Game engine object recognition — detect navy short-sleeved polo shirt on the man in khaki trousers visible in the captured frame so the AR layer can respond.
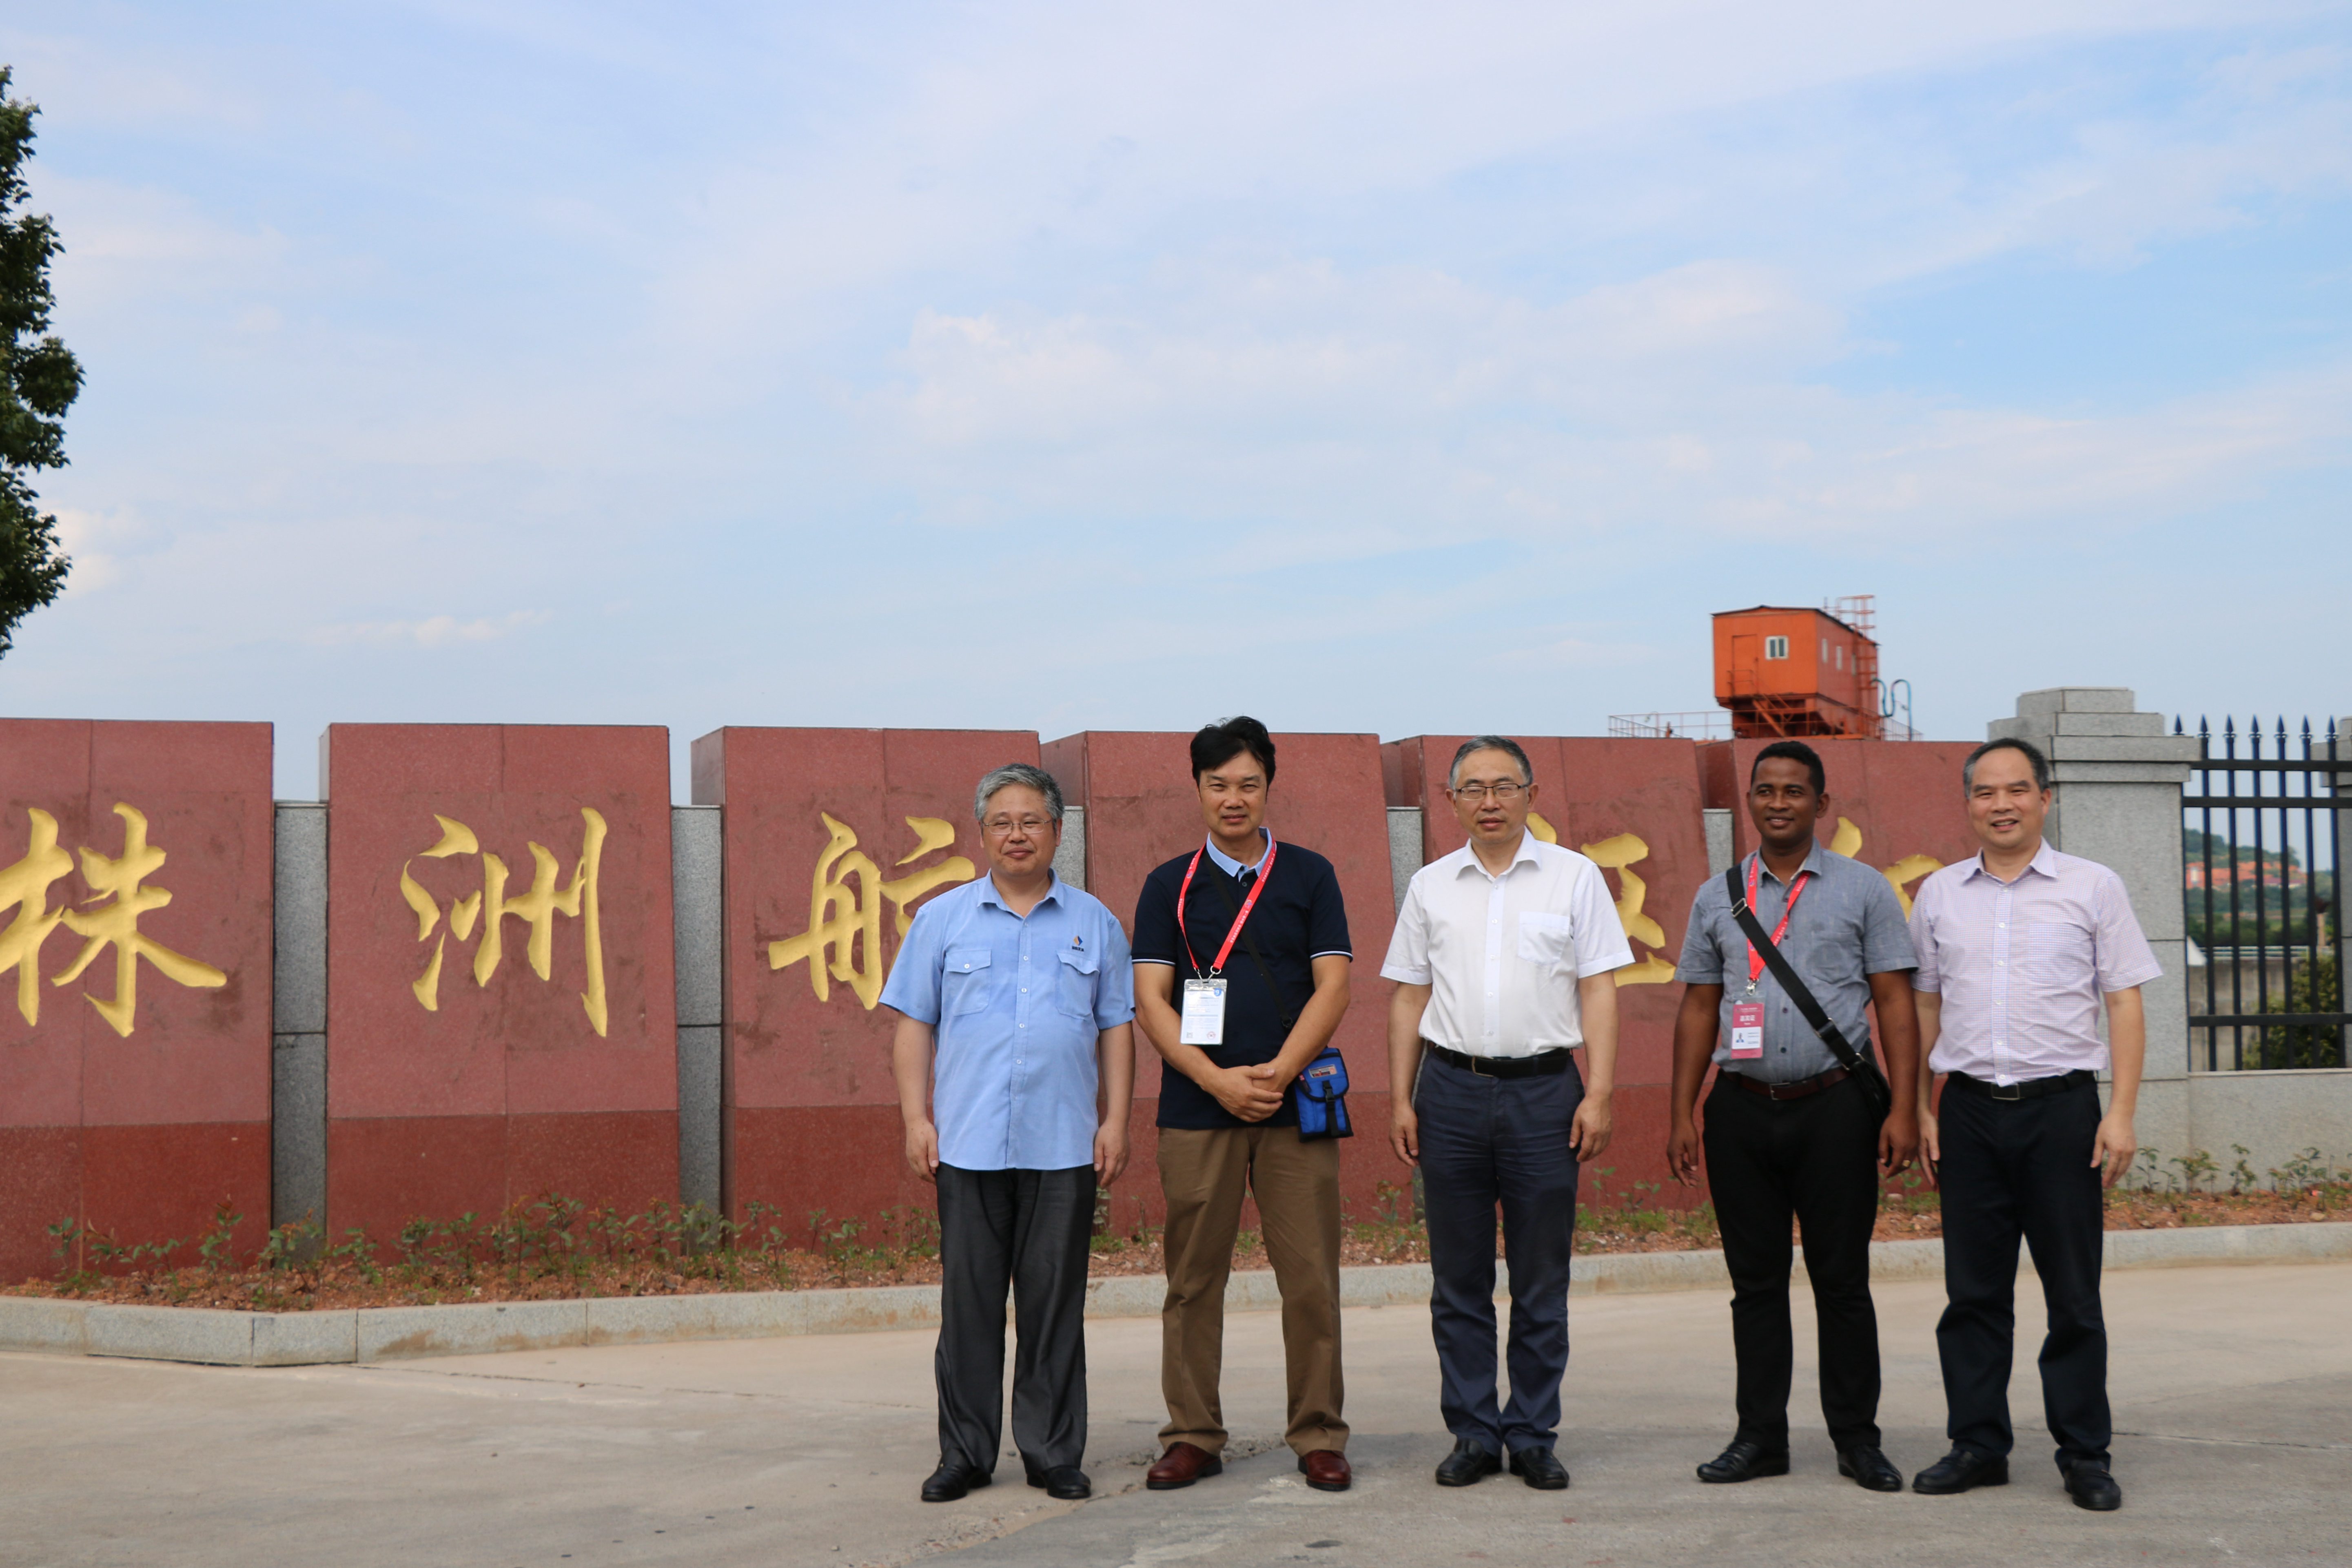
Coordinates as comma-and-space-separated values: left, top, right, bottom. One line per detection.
1136, 839, 1355, 1128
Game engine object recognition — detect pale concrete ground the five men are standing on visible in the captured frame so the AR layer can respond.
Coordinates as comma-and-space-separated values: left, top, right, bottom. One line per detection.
0, 1265, 2352, 1568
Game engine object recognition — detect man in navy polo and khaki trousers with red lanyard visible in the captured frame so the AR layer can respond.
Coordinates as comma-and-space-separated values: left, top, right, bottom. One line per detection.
1136, 720, 1352, 1493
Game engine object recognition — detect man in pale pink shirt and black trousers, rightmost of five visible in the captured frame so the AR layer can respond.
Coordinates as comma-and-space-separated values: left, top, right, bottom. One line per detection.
1912, 740, 2161, 1512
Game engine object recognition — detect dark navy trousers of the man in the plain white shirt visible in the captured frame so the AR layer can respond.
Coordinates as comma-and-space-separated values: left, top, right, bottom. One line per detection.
1414, 1056, 1585, 1453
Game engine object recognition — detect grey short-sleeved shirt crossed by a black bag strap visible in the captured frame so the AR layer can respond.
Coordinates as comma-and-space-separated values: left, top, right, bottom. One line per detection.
1675, 844, 1919, 1084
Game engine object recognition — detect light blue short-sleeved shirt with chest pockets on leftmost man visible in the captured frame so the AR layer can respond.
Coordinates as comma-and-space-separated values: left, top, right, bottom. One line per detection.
882, 877, 1136, 1171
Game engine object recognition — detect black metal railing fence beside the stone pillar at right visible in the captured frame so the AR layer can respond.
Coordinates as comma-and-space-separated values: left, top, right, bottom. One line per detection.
2173, 717, 2352, 1072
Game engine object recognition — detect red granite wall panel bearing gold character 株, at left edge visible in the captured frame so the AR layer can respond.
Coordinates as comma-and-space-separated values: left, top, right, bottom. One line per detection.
0, 720, 273, 1281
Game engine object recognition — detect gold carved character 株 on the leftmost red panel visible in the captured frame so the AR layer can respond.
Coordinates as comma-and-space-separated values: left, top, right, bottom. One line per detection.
0, 802, 228, 1034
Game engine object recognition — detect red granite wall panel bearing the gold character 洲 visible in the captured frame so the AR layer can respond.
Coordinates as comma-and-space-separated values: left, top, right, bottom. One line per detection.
320, 724, 677, 1241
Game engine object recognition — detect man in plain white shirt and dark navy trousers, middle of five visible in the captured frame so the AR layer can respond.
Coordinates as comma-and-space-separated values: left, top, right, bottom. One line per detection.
1381, 736, 1632, 1490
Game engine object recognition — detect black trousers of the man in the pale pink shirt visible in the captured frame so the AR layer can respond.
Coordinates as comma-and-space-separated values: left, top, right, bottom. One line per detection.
1936, 1084, 2115, 1469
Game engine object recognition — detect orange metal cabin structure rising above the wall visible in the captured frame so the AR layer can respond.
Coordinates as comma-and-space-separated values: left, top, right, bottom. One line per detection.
1715, 595, 1886, 740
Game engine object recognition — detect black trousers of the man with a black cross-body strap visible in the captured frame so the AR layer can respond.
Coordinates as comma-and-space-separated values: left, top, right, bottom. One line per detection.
1705, 1074, 1879, 1451
